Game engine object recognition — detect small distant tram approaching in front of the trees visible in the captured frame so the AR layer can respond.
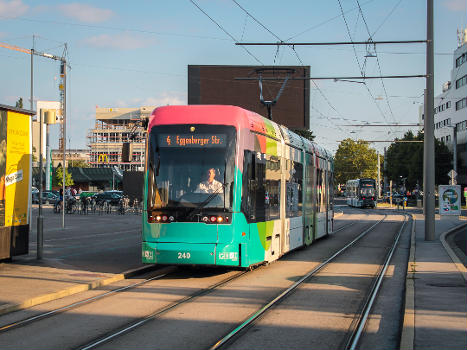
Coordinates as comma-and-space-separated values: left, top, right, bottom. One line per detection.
346, 179, 376, 208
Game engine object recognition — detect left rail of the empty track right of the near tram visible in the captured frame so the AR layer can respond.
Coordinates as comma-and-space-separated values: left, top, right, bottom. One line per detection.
209, 214, 387, 350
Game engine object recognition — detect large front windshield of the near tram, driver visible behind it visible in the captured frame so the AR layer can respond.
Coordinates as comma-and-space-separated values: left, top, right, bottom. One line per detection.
148, 125, 236, 211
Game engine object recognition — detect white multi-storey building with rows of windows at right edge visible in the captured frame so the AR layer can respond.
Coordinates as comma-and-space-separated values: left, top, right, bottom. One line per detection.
420, 29, 467, 186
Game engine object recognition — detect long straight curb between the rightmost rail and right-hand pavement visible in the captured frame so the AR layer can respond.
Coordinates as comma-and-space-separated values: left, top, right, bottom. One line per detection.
399, 214, 417, 350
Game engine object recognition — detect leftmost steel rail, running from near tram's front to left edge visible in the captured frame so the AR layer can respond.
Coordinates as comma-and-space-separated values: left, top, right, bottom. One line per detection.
0, 272, 170, 333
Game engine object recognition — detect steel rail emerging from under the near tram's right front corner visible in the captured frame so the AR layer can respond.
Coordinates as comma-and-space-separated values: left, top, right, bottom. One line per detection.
78, 271, 249, 350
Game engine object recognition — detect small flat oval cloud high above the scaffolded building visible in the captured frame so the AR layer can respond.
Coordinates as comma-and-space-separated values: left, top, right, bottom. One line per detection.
84, 33, 152, 50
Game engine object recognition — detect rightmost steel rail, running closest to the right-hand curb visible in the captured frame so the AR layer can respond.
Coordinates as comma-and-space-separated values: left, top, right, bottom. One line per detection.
345, 215, 407, 350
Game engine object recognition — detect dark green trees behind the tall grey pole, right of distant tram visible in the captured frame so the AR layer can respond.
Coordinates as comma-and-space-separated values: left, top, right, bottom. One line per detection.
385, 131, 452, 189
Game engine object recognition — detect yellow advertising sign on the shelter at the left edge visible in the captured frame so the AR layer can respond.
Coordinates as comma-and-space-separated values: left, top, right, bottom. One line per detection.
5, 111, 31, 226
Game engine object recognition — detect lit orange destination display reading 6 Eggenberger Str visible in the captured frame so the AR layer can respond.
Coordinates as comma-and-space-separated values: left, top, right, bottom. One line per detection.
158, 134, 227, 148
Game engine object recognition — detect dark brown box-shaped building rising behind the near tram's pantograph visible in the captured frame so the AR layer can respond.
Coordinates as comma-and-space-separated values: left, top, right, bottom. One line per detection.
188, 65, 310, 129
